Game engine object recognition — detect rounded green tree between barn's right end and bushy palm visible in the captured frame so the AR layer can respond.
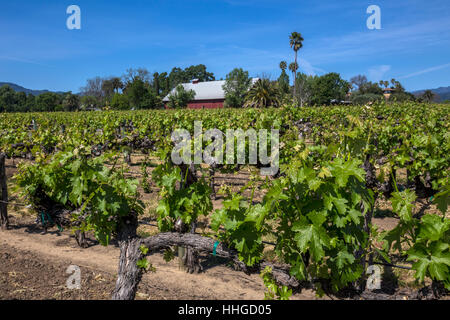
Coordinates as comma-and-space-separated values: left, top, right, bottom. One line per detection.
223, 68, 252, 108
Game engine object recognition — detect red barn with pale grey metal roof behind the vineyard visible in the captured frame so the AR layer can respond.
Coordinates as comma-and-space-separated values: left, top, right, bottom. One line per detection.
163, 79, 257, 109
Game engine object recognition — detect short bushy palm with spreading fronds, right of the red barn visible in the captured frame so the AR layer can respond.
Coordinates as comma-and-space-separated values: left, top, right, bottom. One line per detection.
244, 79, 280, 108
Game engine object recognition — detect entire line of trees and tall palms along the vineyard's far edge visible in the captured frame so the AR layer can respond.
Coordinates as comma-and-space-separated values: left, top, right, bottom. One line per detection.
0, 32, 442, 112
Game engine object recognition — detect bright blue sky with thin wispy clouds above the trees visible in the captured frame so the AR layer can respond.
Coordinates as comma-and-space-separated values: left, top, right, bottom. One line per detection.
0, 0, 450, 92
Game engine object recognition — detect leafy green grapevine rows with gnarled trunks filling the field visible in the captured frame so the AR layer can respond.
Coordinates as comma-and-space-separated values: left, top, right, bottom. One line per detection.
0, 102, 450, 300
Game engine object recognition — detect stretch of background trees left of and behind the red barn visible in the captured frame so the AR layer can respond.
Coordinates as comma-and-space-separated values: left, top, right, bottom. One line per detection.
0, 64, 215, 112
